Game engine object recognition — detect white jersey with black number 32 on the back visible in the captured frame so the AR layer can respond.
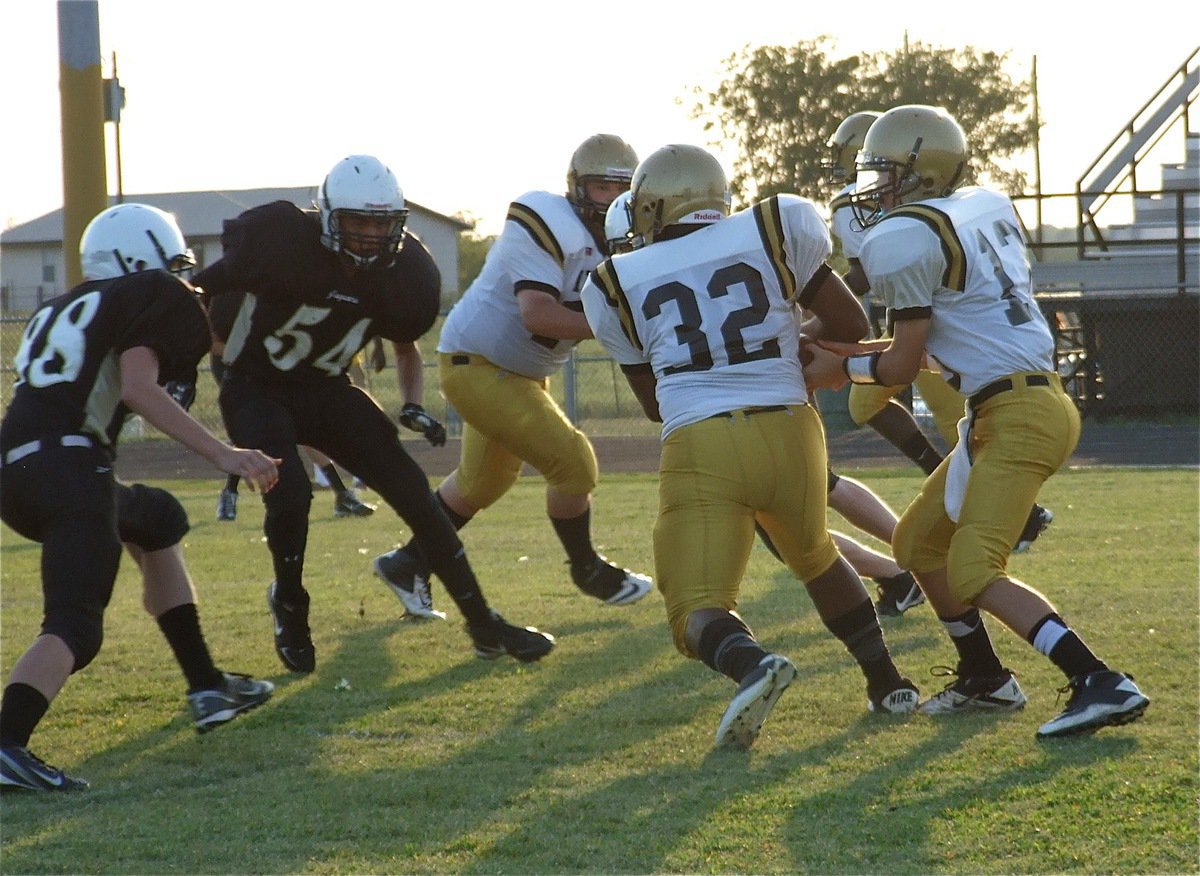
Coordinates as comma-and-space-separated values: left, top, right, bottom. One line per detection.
583, 194, 830, 436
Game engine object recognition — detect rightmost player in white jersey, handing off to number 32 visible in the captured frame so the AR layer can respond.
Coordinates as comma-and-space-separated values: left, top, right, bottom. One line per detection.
812, 106, 1150, 737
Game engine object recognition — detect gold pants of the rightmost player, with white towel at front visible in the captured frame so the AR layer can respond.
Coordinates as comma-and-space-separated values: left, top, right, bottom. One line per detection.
892, 372, 1080, 602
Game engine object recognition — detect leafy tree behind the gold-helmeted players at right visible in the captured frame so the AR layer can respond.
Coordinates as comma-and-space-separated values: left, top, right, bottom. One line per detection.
691, 36, 1034, 204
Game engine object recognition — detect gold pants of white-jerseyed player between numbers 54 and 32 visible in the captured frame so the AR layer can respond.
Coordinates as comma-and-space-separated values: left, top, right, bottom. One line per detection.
438, 353, 600, 509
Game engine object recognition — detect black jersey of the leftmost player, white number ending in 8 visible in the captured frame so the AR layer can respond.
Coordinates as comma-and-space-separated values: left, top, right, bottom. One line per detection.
0, 271, 211, 450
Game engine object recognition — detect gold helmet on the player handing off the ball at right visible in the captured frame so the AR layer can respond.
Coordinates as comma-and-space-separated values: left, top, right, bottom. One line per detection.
850, 103, 968, 227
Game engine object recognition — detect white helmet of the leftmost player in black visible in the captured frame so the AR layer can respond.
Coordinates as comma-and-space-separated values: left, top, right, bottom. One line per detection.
79, 204, 196, 280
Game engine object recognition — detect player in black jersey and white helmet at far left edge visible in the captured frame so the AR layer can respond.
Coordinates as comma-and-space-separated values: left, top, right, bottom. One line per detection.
0, 204, 278, 791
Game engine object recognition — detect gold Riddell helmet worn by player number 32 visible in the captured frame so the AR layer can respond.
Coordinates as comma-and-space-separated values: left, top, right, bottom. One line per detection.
629, 145, 731, 246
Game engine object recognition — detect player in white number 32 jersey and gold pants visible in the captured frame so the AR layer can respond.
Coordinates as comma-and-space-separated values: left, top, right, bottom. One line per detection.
582, 145, 917, 748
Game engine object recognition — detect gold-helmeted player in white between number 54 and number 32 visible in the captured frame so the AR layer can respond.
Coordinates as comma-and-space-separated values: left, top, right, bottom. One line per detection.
374, 134, 654, 605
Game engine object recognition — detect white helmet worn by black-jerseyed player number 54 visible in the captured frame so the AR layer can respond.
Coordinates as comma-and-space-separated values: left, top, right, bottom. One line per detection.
316, 155, 408, 270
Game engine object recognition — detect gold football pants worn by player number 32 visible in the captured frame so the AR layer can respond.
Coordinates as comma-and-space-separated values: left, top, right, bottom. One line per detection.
654, 404, 838, 656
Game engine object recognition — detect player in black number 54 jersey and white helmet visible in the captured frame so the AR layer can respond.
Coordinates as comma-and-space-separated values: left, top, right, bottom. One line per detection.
196, 155, 553, 672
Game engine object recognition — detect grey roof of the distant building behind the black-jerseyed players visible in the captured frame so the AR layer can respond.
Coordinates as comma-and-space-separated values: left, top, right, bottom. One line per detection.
0, 186, 472, 244
